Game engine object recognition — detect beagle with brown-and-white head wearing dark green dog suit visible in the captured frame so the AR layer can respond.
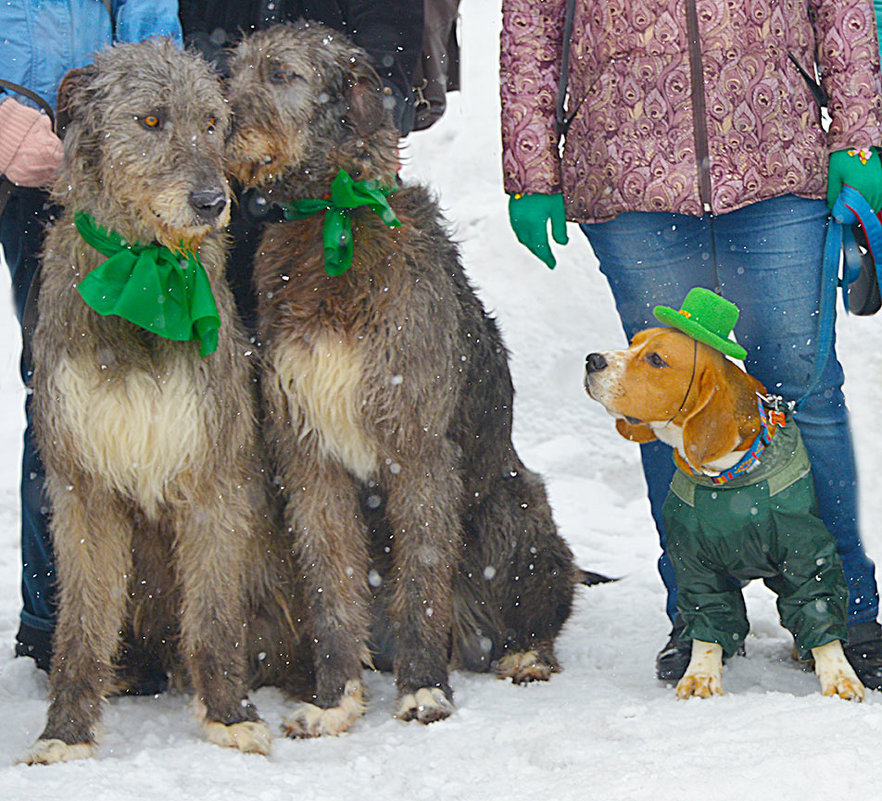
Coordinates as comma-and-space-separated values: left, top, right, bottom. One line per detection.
585, 328, 864, 701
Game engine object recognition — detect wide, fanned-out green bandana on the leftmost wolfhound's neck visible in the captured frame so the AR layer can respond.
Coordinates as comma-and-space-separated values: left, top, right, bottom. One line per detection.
74, 211, 220, 356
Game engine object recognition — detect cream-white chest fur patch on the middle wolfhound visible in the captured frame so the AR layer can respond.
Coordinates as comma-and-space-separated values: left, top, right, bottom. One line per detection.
273, 336, 378, 480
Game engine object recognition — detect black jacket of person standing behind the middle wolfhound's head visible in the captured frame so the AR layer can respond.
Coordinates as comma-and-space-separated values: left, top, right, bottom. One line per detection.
179, 0, 423, 134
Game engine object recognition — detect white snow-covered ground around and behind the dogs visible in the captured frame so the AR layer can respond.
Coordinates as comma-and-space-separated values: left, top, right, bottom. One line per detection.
0, 0, 882, 801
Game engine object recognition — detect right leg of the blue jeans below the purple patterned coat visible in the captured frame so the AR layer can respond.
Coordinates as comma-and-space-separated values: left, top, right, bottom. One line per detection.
713, 196, 879, 625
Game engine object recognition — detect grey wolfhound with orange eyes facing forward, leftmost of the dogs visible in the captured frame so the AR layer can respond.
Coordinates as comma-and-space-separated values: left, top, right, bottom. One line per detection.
23, 42, 310, 763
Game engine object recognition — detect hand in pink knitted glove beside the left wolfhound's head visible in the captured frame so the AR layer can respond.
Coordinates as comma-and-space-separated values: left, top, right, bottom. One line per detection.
0, 97, 63, 186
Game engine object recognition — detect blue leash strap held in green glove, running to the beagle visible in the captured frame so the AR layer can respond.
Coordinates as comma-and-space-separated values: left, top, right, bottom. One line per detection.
796, 186, 882, 409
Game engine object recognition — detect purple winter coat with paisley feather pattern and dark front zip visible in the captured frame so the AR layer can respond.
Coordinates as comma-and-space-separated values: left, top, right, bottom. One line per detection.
500, 0, 882, 222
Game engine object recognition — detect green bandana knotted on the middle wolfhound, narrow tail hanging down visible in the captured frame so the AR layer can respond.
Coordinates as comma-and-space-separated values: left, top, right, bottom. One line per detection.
279, 170, 401, 276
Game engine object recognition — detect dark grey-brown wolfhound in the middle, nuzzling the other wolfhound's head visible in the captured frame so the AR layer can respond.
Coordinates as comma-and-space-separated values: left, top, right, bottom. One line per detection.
228, 23, 581, 737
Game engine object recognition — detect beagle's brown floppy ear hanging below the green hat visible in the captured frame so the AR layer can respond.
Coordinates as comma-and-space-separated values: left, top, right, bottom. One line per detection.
683, 363, 741, 470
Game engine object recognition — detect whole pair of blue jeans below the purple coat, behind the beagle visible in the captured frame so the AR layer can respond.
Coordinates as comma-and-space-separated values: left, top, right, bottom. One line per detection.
582, 195, 879, 625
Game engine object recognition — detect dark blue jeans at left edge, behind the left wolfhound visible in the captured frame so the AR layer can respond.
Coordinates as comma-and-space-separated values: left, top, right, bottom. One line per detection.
0, 188, 55, 631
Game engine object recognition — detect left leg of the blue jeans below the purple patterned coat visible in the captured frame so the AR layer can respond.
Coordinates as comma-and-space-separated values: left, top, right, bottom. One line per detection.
582, 212, 717, 622
